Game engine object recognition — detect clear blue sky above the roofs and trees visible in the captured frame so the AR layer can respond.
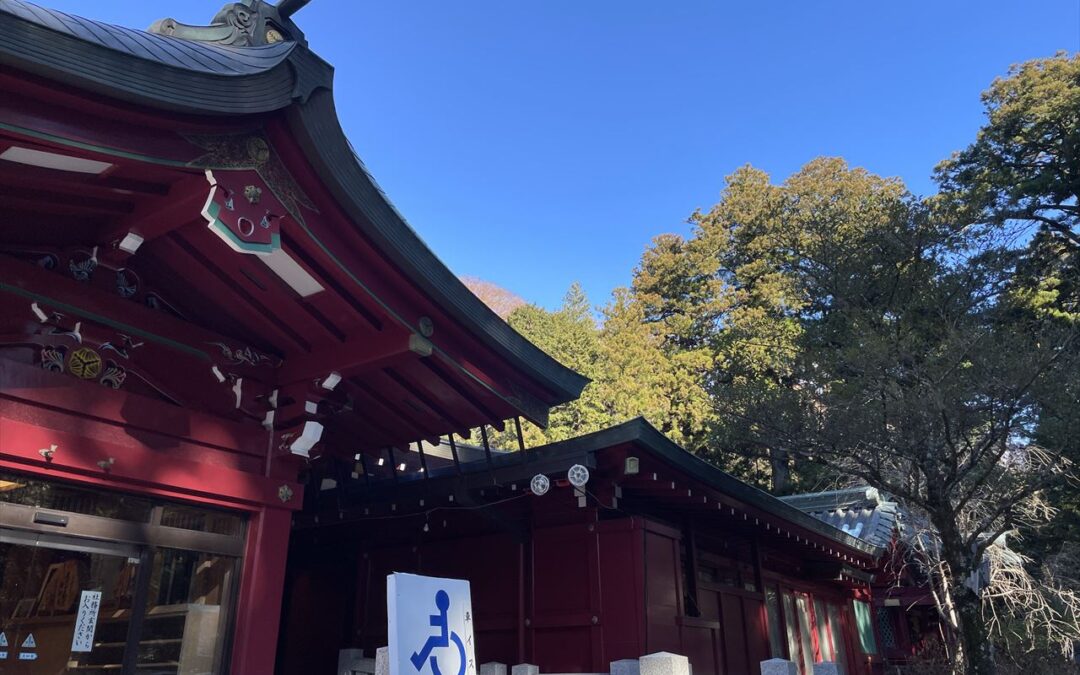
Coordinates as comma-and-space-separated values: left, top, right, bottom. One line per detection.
40, 0, 1080, 307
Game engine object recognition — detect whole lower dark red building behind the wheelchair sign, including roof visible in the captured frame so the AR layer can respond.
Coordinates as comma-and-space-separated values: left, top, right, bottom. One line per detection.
280, 419, 883, 675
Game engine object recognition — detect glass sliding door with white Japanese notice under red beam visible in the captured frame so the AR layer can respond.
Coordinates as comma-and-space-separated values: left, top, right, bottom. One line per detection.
0, 474, 245, 675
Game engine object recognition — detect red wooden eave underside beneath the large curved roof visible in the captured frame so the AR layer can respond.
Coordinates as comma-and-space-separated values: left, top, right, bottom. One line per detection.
0, 77, 574, 457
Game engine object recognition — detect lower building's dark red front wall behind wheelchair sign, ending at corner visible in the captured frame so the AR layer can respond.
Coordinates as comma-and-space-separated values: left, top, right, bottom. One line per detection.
278, 518, 645, 675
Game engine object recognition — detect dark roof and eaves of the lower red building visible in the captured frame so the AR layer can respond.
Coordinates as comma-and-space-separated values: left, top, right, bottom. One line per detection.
297, 419, 882, 570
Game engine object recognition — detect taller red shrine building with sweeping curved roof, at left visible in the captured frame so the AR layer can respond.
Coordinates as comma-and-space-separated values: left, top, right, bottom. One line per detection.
0, 0, 585, 674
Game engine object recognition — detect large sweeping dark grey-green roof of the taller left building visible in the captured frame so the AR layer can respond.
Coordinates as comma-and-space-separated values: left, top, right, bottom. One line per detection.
0, 0, 589, 405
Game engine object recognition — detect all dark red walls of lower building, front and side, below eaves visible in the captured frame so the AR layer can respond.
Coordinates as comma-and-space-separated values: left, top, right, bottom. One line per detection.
279, 509, 861, 675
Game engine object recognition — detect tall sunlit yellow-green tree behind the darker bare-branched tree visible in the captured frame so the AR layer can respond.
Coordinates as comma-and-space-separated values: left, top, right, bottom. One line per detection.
634, 160, 908, 494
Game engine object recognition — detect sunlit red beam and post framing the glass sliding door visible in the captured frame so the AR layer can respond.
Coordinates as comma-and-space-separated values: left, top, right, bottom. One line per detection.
0, 357, 302, 674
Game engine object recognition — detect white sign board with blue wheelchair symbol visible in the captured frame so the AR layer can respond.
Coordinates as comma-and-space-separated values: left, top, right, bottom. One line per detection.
387, 573, 476, 675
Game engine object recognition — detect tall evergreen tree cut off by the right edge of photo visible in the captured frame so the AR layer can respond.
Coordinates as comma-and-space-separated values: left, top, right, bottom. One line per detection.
933, 54, 1080, 652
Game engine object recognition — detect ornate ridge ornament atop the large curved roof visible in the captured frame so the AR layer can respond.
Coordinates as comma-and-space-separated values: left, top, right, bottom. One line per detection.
150, 0, 311, 46
